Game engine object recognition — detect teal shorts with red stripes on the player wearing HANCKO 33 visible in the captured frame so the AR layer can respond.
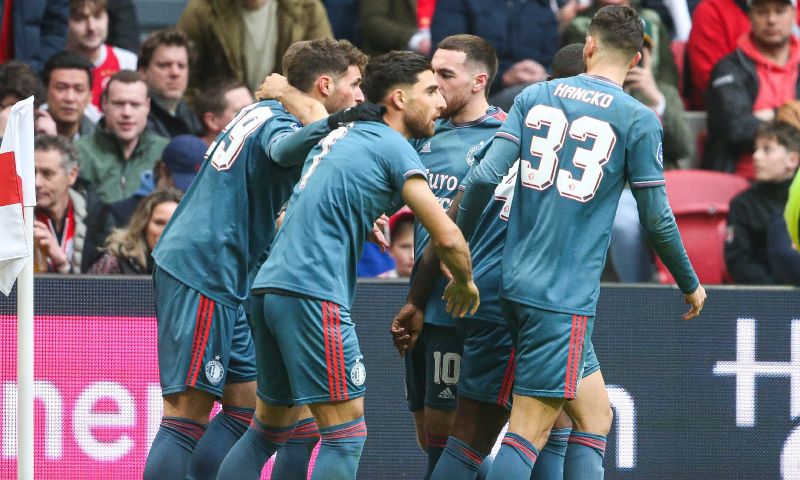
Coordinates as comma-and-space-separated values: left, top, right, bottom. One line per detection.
500, 299, 599, 400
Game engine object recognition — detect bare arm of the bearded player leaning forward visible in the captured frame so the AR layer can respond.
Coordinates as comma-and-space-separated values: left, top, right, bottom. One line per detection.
402, 176, 480, 317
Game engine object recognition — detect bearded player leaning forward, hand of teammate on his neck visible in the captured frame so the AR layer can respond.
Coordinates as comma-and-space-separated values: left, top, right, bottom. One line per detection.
219, 52, 478, 479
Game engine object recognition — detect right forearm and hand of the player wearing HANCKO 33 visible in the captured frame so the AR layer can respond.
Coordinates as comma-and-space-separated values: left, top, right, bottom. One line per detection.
631, 185, 706, 320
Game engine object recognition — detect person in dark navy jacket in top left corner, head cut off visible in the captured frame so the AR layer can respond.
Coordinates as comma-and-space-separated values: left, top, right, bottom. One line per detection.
0, 0, 69, 73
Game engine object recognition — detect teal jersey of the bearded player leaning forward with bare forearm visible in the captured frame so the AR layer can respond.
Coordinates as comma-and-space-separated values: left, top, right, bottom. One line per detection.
253, 122, 425, 308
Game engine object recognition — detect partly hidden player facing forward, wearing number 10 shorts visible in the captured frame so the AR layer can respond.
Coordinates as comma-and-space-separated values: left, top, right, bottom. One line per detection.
405, 35, 506, 480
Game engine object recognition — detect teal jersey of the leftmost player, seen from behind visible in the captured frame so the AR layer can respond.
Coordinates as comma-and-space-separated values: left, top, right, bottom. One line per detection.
153, 100, 302, 308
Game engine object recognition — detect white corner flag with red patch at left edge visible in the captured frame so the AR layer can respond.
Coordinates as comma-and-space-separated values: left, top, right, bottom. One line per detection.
0, 97, 36, 295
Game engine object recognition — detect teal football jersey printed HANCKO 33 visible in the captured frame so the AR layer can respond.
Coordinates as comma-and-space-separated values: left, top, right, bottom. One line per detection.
465, 74, 664, 315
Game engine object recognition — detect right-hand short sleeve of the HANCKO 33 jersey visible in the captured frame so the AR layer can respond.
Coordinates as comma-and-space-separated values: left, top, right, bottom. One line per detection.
625, 111, 665, 189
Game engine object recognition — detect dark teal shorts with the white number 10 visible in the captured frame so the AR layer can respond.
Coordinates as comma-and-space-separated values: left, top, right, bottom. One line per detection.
405, 323, 461, 412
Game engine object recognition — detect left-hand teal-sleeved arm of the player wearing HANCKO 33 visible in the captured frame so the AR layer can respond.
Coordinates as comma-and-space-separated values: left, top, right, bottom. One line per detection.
457, 136, 519, 239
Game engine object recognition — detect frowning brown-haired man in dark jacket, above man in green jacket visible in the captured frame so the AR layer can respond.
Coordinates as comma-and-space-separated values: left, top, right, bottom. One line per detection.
139, 28, 203, 138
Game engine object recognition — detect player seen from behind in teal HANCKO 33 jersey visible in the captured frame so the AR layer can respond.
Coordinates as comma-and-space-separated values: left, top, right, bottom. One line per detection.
450, 6, 705, 480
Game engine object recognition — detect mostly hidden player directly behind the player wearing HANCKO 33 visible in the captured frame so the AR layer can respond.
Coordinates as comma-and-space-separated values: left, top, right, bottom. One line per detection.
396, 44, 599, 480
